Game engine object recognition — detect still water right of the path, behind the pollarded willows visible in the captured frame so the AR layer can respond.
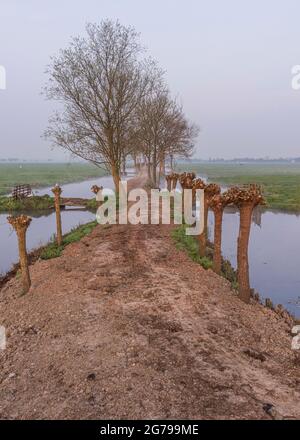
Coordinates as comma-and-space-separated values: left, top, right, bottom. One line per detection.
209, 208, 300, 316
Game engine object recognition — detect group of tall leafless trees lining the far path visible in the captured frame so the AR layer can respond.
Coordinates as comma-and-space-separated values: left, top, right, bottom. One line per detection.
45, 20, 199, 189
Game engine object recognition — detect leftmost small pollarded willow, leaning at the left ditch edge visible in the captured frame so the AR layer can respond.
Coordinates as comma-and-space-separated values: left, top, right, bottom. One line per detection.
7, 215, 32, 294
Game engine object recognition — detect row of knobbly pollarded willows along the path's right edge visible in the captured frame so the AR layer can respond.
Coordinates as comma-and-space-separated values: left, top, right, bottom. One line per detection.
166, 173, 265, 303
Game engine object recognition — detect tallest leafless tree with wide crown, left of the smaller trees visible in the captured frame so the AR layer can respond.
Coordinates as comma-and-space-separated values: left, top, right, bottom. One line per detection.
45, 20, 161, 189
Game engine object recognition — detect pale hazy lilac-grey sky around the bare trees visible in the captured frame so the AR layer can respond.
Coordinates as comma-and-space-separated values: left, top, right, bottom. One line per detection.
0, 0, 300, 160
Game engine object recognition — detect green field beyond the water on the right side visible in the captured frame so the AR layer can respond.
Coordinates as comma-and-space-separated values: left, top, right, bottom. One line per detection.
177, 163, 300, 212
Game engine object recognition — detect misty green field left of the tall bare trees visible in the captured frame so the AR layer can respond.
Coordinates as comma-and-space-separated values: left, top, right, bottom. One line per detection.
0, 163, 105, 195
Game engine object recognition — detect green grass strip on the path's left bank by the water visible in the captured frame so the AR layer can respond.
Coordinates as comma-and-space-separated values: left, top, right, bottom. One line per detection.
40, 221, 98, 260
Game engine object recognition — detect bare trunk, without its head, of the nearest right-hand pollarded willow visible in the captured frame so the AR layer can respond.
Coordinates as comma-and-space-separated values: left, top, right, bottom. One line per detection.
237, 204, 253, 303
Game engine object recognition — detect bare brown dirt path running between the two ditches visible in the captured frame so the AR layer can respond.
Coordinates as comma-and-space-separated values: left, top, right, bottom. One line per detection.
0, 172, 300, 419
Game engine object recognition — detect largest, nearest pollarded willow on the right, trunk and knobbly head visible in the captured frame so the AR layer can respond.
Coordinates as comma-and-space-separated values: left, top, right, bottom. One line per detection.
228, 184, 265, 303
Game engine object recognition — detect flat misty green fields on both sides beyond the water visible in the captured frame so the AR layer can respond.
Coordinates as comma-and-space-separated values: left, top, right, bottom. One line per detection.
0, 163, 300, 212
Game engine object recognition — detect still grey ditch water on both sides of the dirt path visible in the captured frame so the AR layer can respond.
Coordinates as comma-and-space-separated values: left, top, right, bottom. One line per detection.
0, 176, 300, 318
